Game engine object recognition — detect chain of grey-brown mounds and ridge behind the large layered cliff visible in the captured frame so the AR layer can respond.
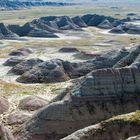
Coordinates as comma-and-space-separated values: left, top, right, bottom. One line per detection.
6, 48, 129, 83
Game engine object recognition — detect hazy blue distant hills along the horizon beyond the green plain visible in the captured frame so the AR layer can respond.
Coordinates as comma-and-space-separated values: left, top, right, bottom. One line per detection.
0, 0, 140, 10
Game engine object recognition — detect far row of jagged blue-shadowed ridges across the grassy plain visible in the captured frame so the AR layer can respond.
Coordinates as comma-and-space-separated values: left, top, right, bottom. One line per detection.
6, 14, 140, 38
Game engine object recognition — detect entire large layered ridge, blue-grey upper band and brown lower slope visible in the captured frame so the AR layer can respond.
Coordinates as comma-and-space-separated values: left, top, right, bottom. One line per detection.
15, 46, 140, 140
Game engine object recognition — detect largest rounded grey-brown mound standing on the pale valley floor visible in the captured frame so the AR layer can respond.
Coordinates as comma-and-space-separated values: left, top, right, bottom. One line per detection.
16, 59, 69, 83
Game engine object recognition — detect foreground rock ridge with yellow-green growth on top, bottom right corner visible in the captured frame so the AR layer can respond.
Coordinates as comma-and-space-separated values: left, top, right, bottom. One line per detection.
61, 112, 140, 140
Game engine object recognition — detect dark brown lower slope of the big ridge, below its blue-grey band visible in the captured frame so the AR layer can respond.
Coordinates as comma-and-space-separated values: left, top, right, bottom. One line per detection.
15, 94, 140, 140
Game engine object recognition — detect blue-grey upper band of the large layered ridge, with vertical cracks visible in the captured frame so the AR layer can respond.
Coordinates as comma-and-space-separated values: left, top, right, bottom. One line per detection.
72, 65, 140, 98
